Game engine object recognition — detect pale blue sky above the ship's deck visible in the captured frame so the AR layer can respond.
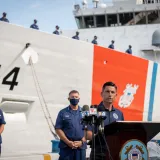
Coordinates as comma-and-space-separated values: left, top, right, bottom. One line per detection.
0, 0, 111, 32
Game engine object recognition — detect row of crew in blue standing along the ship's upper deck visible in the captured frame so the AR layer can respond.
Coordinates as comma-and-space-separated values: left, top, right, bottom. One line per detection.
0, 12, 132, 54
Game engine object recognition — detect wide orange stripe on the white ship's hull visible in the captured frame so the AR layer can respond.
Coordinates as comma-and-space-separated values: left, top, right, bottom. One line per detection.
92, 46, 149, 121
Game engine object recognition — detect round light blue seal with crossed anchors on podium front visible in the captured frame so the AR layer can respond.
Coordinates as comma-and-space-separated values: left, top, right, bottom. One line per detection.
120, 139, 148, 160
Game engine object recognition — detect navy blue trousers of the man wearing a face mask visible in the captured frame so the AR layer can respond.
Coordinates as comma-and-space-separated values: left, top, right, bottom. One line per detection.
59, 147, 86, 160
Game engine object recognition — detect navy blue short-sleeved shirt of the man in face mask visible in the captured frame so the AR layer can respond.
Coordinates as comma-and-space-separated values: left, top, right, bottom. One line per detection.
55, 106, 86, 149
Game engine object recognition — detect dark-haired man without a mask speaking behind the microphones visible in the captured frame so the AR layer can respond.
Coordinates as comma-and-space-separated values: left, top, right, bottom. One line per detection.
87, 82, 124, 160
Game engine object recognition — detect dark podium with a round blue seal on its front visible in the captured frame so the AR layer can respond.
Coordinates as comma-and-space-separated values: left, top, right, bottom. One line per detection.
89, 121, 160, 160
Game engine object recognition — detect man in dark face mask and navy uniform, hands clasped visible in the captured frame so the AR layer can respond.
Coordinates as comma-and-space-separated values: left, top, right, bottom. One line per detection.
55, 90, 87, 160
